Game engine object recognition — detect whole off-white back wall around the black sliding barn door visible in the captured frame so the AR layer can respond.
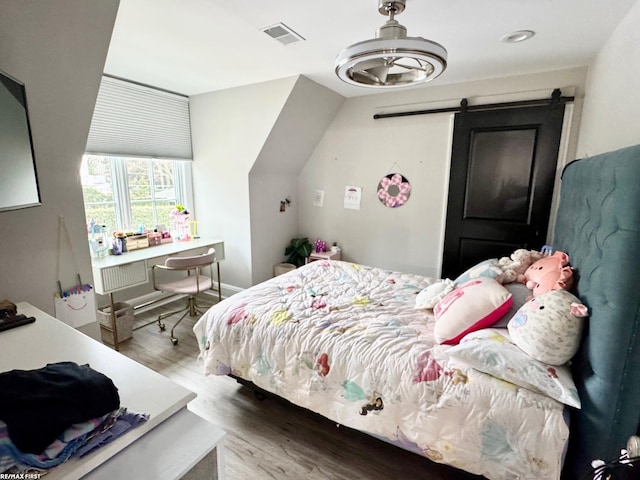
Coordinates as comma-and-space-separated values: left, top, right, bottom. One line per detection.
298, 68, 586, 276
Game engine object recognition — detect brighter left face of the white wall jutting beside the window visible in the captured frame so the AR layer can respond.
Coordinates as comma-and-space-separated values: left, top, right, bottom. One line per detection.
190, 77, 296, 288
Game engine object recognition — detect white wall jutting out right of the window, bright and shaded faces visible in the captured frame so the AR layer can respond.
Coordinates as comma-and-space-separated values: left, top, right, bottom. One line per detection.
191, 76, 344, 290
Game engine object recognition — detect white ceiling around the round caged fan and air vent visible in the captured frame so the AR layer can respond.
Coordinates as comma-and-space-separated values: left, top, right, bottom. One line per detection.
105, 0, 637, 97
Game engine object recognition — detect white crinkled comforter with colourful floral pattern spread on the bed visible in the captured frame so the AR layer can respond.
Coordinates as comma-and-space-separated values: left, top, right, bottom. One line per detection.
194, 261, 569, 480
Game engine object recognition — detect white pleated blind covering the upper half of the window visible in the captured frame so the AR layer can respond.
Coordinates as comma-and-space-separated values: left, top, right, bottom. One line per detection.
86, 76, 193, 160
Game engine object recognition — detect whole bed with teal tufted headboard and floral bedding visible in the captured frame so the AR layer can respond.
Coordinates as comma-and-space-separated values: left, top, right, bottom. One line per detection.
194, 146, 640, 480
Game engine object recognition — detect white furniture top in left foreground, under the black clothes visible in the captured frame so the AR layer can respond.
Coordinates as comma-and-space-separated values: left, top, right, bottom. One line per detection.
0, 302, 224, 480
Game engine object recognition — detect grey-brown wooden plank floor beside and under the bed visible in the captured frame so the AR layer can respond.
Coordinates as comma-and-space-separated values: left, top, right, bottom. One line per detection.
120, 296, 483, 480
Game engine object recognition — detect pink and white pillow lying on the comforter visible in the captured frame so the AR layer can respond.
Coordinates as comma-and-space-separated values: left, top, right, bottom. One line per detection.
433, 277, 513, 345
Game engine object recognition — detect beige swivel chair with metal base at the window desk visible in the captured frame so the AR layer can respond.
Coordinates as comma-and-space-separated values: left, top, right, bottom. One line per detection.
151, 248, 216, 345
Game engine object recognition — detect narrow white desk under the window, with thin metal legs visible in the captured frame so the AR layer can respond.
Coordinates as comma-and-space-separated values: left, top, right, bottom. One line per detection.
91, 238, 224, 350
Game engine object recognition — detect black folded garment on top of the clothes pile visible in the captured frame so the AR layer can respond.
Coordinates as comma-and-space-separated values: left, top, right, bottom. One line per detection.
0, 362, 120, 454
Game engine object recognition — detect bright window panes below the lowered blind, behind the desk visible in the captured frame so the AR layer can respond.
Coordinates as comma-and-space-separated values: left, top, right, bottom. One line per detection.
80, 155, 191, 232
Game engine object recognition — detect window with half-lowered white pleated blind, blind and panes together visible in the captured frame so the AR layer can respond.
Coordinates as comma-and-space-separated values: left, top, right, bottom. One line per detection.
85, 75, 193, 236
